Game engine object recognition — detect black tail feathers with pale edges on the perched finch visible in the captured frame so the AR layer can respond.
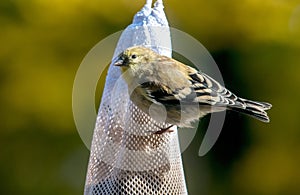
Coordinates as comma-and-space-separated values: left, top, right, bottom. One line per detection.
230, 98, 272, 123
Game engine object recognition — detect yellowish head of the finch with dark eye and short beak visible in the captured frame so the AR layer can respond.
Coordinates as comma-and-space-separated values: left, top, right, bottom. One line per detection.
113, 46, 153, 71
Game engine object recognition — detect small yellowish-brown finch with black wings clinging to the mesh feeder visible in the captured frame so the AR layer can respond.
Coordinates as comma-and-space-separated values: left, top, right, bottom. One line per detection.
112, 46, 272, 134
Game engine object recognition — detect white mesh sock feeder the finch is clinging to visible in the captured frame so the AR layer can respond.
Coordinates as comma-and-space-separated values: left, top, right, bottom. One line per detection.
84, 0, 187, 195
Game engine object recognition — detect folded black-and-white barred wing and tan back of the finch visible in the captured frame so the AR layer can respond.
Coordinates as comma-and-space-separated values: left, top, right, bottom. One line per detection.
141, 56, 246, 108
